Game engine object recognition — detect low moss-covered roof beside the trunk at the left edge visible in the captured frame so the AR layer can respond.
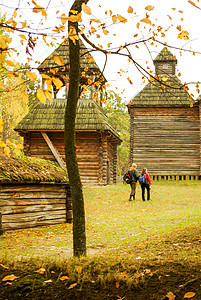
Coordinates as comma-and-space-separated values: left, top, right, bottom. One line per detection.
0, 154, 68, 183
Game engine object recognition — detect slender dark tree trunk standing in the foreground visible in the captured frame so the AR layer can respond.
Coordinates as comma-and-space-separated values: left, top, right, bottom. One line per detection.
64, 0, 88, 257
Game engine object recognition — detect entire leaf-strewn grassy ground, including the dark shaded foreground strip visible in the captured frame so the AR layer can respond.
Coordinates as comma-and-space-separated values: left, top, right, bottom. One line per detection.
0, 181, 201, 300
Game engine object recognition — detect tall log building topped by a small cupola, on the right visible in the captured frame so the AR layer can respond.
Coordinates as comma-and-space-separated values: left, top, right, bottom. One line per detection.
127, 47, 201, 180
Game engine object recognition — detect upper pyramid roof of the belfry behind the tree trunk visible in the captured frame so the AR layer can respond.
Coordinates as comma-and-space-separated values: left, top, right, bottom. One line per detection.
38, 39, 106, 81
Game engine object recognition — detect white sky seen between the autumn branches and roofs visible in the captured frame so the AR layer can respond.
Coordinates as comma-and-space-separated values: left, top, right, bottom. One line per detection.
0, 0, 201, 102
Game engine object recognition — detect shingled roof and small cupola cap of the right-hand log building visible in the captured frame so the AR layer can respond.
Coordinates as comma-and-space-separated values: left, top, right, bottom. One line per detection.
128, 48, 194, 106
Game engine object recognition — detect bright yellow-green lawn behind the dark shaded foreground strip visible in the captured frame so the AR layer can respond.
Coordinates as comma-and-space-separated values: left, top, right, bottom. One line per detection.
0, 181, 201, 261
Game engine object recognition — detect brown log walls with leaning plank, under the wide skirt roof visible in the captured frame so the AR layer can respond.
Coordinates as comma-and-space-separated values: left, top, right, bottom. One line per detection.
24, 131, 117, 186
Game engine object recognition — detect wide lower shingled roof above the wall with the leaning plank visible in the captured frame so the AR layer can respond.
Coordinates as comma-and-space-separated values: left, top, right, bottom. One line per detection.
15, 99, 120, 141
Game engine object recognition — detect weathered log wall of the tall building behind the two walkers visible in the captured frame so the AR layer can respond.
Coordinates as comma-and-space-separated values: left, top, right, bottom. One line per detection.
130, 106, 200, 176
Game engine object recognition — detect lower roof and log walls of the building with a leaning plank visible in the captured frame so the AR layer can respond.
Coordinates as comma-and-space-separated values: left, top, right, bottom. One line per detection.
15, 99, 121, 186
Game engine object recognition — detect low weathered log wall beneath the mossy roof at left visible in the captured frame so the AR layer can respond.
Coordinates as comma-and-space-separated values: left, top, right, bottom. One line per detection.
0, 183, 72, 231
